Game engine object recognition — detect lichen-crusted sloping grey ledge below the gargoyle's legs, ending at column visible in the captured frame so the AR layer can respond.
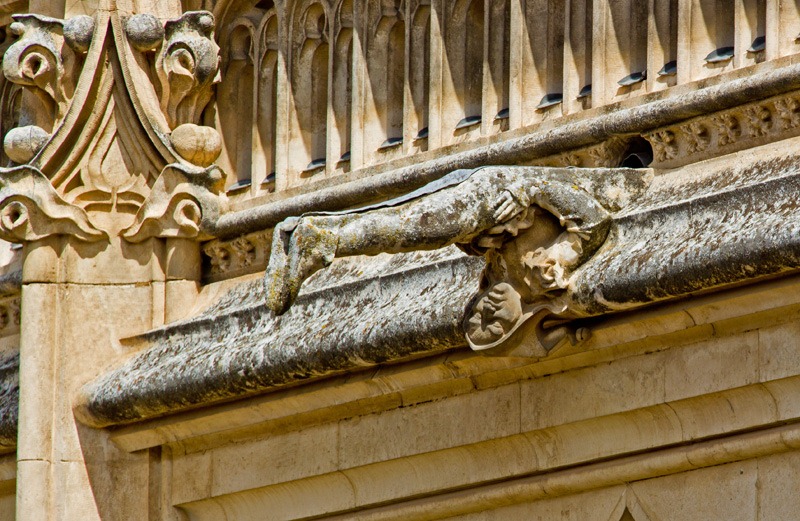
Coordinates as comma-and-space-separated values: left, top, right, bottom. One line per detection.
77, 248, 483, 425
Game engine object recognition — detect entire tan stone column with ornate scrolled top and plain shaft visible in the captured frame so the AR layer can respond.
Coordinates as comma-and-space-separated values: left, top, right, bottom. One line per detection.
0, 3, 223, 521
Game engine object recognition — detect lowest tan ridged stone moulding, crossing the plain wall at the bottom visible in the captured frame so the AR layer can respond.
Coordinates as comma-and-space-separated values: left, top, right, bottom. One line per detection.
178, 384, 800, 521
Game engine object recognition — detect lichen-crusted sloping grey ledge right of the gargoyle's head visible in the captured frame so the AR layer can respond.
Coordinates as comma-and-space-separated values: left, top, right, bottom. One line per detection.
572, 152, 800, 315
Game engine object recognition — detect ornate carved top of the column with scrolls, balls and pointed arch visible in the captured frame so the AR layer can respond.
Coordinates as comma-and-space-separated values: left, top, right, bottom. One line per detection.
0, 11, 224, 242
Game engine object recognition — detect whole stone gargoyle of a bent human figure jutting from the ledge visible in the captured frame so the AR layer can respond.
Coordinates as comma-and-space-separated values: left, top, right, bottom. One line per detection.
265, 166, 652, 357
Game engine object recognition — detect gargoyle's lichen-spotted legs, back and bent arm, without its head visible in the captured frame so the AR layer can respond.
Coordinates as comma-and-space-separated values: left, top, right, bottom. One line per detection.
265, 167, 608, 314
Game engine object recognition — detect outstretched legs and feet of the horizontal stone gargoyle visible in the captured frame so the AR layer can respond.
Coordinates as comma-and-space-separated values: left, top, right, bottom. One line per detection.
265, 169, 528, 314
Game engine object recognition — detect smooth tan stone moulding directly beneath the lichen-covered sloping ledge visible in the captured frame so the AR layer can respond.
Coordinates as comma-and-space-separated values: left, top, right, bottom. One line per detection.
103, 270, 800, 452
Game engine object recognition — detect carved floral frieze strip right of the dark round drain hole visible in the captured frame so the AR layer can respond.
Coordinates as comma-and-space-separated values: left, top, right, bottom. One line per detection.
644, 93, 800, 168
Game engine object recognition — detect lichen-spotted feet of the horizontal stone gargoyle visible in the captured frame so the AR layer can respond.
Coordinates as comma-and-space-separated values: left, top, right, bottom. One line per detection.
265, 218, 338, 315
